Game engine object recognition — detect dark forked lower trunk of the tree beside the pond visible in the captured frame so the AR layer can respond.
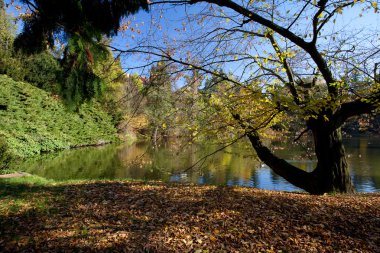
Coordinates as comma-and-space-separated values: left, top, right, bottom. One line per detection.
247, 126, 354, 194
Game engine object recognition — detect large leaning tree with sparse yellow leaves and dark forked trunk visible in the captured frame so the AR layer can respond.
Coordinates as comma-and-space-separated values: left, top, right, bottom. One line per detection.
116, 0, 380, 194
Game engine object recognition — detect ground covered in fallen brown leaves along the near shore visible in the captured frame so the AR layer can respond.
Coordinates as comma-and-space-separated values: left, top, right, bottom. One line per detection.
0, 181, 380, 252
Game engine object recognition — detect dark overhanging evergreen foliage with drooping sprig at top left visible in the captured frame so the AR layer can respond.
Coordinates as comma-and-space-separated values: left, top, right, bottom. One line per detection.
14, 0, 148, 106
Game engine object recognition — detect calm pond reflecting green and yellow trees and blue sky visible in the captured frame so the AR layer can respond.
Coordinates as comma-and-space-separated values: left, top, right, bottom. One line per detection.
13, 137, 380, 192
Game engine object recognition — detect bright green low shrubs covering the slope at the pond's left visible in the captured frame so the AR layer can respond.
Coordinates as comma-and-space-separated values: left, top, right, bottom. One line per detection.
0, 75, 116, 160
